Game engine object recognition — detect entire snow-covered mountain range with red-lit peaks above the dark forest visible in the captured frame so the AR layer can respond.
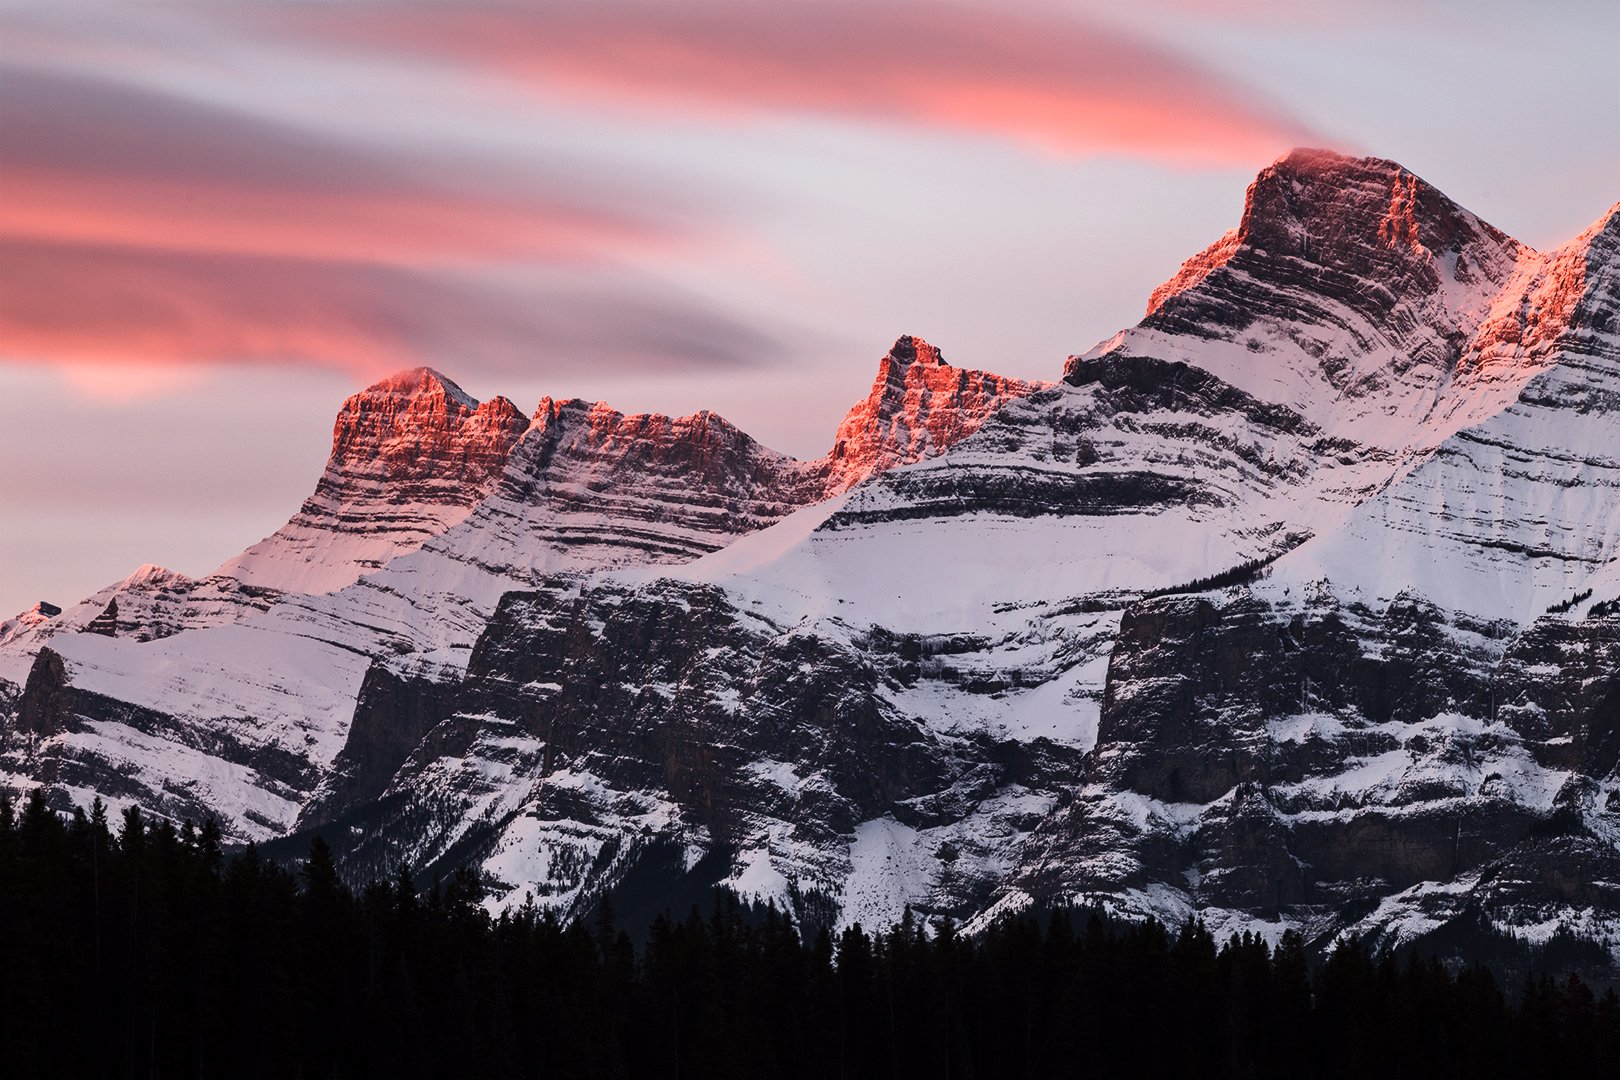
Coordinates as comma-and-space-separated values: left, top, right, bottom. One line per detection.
0, 151, 1620, 965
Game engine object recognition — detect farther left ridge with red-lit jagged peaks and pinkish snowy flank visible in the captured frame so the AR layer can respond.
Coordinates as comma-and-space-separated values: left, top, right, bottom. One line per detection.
0, 337, 1037, 839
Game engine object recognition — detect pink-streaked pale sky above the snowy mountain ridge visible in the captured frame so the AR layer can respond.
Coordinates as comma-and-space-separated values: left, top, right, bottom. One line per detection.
0, 0, 1620, 617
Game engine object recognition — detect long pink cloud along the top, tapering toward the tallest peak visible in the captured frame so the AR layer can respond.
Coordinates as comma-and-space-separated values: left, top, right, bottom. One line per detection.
272, 0, 1309, 165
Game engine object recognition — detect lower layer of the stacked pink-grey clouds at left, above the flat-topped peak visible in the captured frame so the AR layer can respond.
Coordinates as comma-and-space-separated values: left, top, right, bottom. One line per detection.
0, 240, 779, 376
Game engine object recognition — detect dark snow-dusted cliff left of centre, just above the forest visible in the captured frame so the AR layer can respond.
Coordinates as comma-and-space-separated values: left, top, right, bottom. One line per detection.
305, 578, 1081, 910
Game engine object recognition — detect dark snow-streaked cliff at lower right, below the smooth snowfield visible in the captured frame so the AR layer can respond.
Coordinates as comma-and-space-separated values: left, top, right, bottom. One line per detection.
1009, 588, 1620, 938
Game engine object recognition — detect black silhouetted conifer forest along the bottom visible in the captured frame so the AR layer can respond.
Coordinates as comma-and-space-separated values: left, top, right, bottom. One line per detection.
0, 793, 1620, 1080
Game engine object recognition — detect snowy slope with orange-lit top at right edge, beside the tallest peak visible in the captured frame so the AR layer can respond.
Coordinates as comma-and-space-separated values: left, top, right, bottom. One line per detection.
1278, 206, 1620, 623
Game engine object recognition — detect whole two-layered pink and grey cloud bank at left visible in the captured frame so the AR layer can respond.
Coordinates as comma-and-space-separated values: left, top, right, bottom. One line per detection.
0, 66, 774, 385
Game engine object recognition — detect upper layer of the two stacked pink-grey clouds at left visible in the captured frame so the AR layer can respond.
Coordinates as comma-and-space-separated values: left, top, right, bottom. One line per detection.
0, 68, 676, 264
